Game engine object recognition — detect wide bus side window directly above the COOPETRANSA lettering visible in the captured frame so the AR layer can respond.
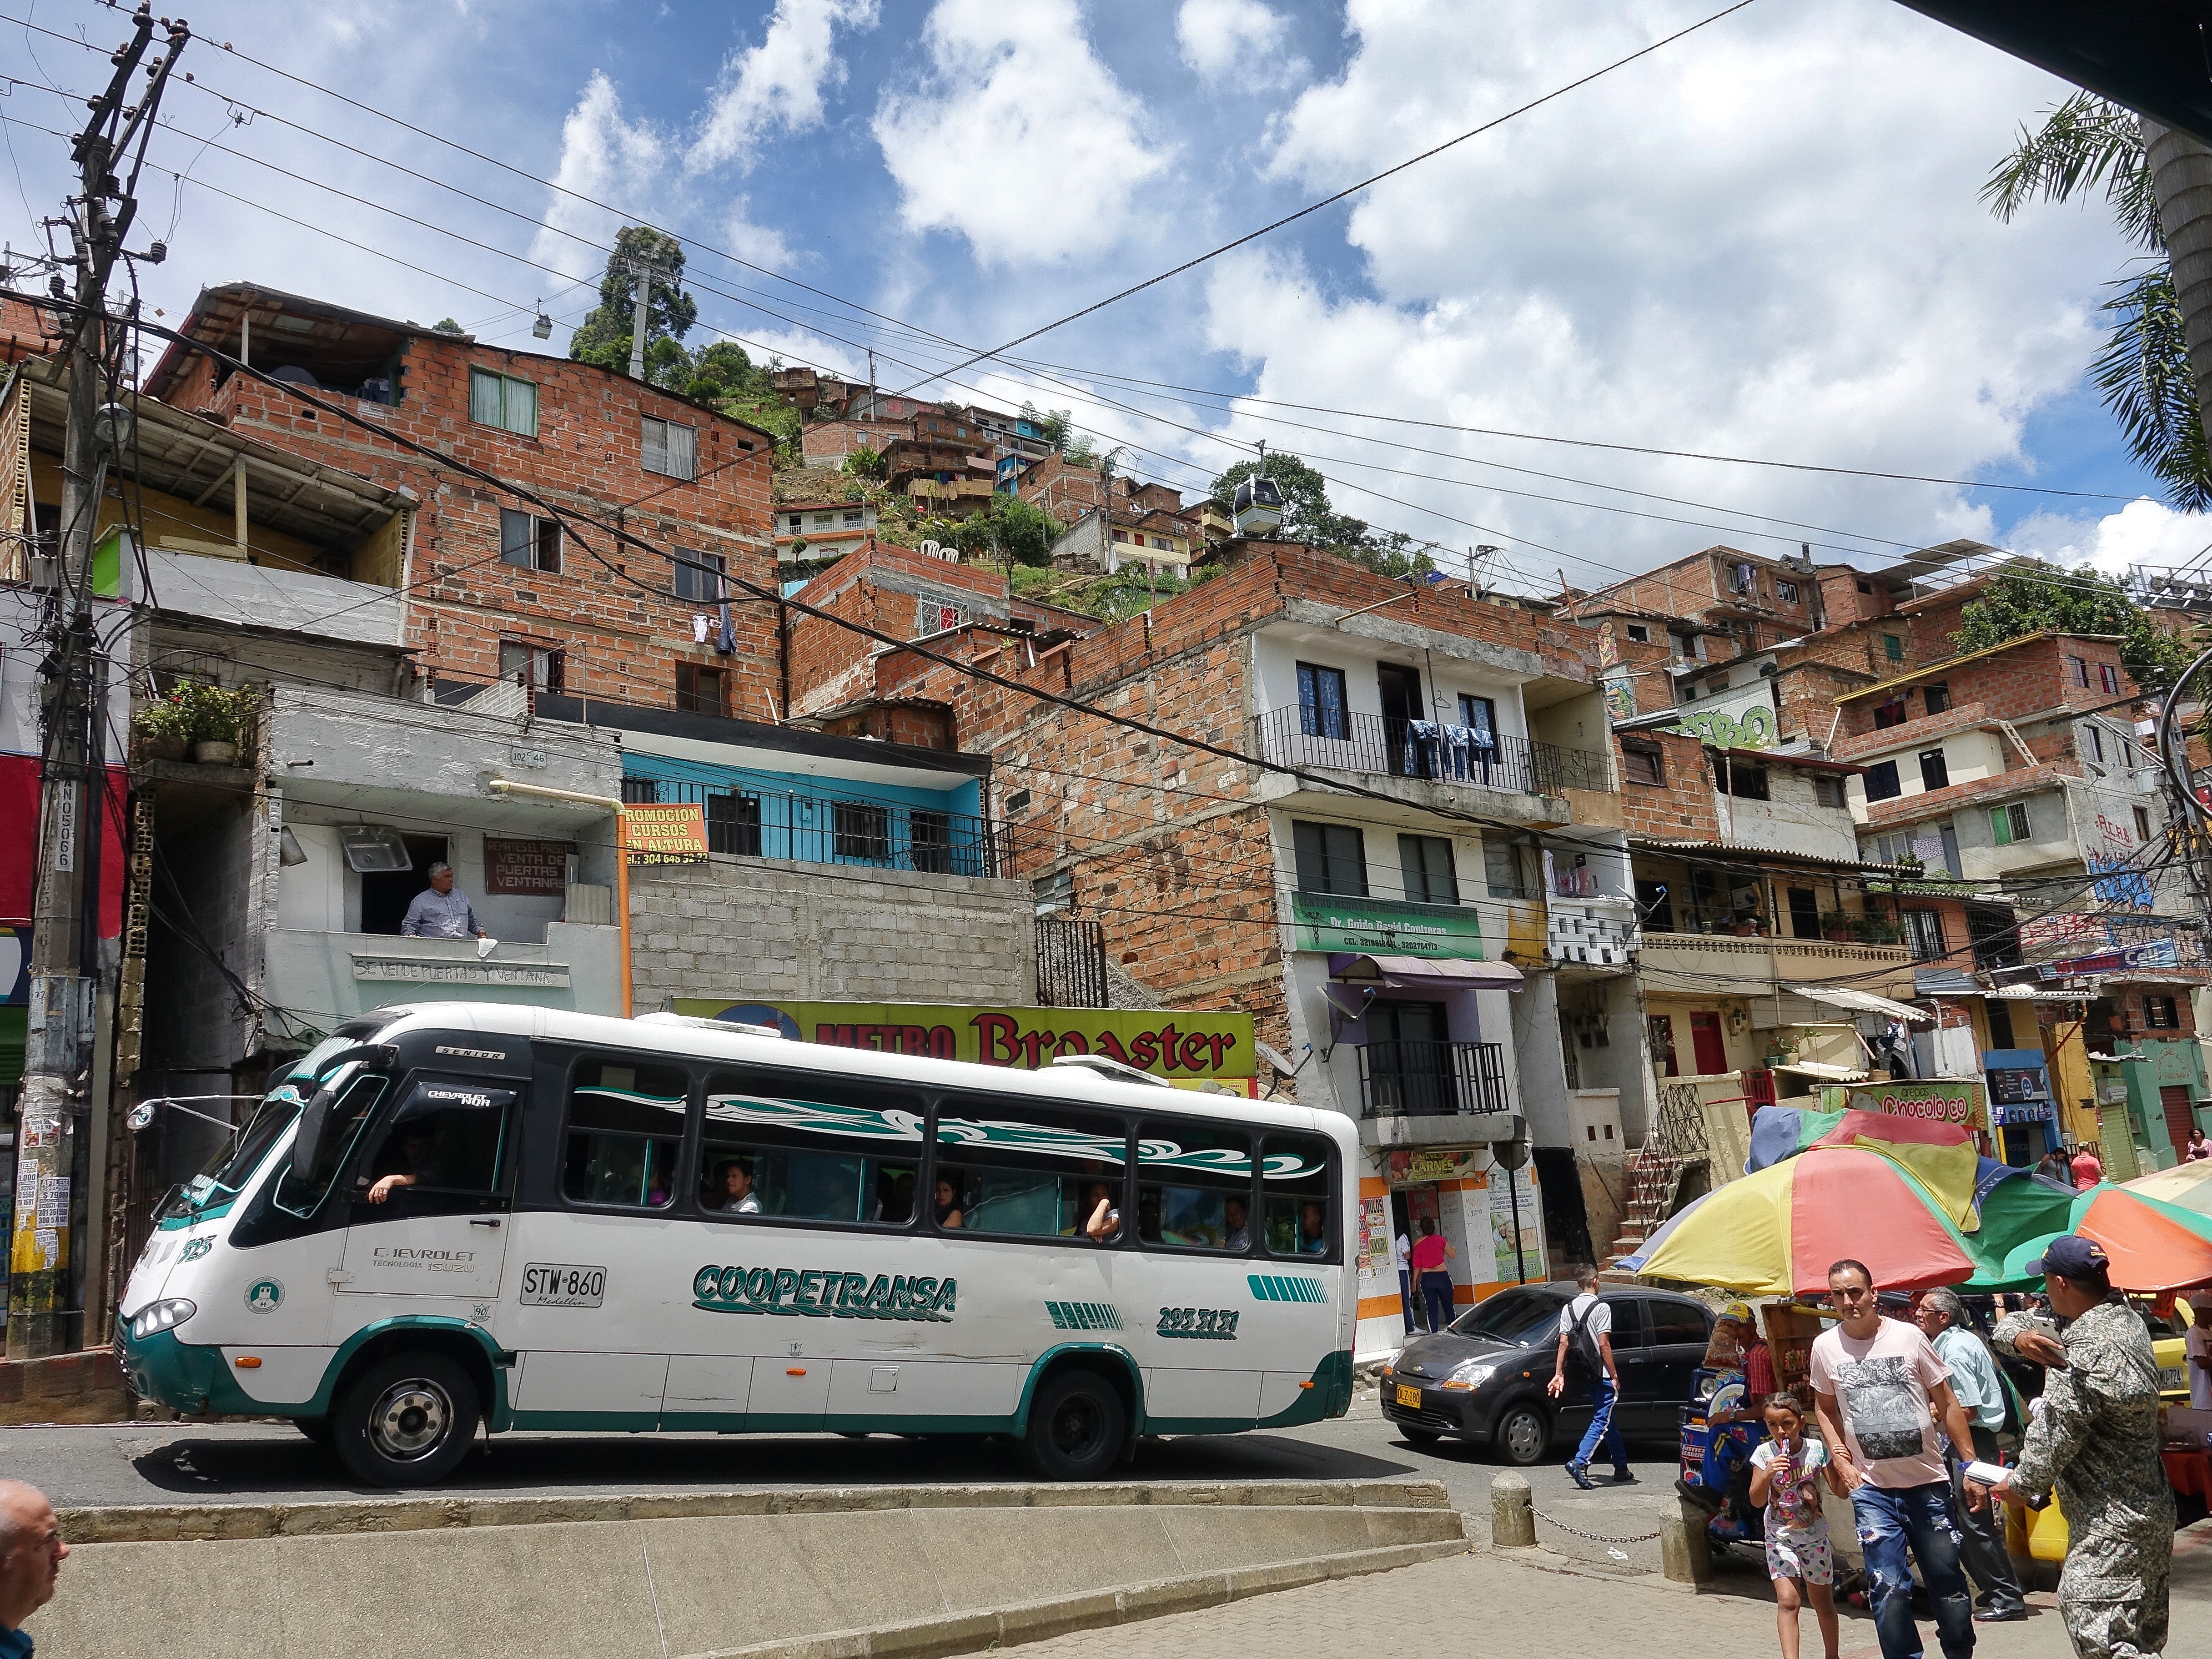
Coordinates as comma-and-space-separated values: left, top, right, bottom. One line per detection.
699, 1071, 922, 1228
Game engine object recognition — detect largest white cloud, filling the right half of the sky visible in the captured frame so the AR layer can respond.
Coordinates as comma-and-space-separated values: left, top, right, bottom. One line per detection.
1192, 0, 2150, 586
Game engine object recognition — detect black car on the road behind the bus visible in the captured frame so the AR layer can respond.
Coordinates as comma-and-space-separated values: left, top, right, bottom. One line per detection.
1382, 1281, 1712, 1464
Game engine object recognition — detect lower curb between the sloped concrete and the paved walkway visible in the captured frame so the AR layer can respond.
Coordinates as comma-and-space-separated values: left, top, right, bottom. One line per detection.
692, 1539, 1467, 1659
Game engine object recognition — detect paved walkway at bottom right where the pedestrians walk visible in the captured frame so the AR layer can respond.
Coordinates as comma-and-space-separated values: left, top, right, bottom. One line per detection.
1022, 1522, 2212, 1659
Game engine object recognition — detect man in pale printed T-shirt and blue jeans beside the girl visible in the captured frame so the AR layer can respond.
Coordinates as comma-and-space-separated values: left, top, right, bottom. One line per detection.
1812, 1261, 1986, 1659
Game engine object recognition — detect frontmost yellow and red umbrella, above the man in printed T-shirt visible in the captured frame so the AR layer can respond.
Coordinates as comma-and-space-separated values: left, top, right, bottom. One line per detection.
1621, 1146, 2011, 1296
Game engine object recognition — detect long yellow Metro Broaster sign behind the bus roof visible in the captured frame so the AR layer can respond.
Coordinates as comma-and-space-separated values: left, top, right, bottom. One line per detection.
675, 998, 1259, 1093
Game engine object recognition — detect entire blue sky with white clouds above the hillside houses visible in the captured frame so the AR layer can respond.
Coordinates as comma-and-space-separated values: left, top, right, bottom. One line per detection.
0, 0, 2212, 591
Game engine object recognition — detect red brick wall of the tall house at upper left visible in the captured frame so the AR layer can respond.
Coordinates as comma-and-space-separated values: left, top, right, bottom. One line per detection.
172, 334, 781, 719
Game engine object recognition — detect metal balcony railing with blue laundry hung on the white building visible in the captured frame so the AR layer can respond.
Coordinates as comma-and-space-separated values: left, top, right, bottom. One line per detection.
1252, 708, 1613, 794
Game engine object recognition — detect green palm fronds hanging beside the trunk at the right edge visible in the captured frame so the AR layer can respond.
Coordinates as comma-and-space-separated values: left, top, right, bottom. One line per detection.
1982, 93, 2212, 513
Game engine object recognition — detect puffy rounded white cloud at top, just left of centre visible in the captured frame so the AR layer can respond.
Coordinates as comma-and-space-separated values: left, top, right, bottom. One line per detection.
876, 0, 1170, 266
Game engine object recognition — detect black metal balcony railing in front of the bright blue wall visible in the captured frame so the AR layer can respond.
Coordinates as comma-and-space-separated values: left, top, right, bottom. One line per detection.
622, 776, 1006, 876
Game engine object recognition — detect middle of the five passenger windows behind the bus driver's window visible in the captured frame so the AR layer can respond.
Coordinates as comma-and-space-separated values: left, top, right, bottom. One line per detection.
931, 1095, 1128, 1245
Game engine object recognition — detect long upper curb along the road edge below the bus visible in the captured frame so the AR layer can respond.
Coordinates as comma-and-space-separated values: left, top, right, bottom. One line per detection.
57, 1480, 1460, 1548
